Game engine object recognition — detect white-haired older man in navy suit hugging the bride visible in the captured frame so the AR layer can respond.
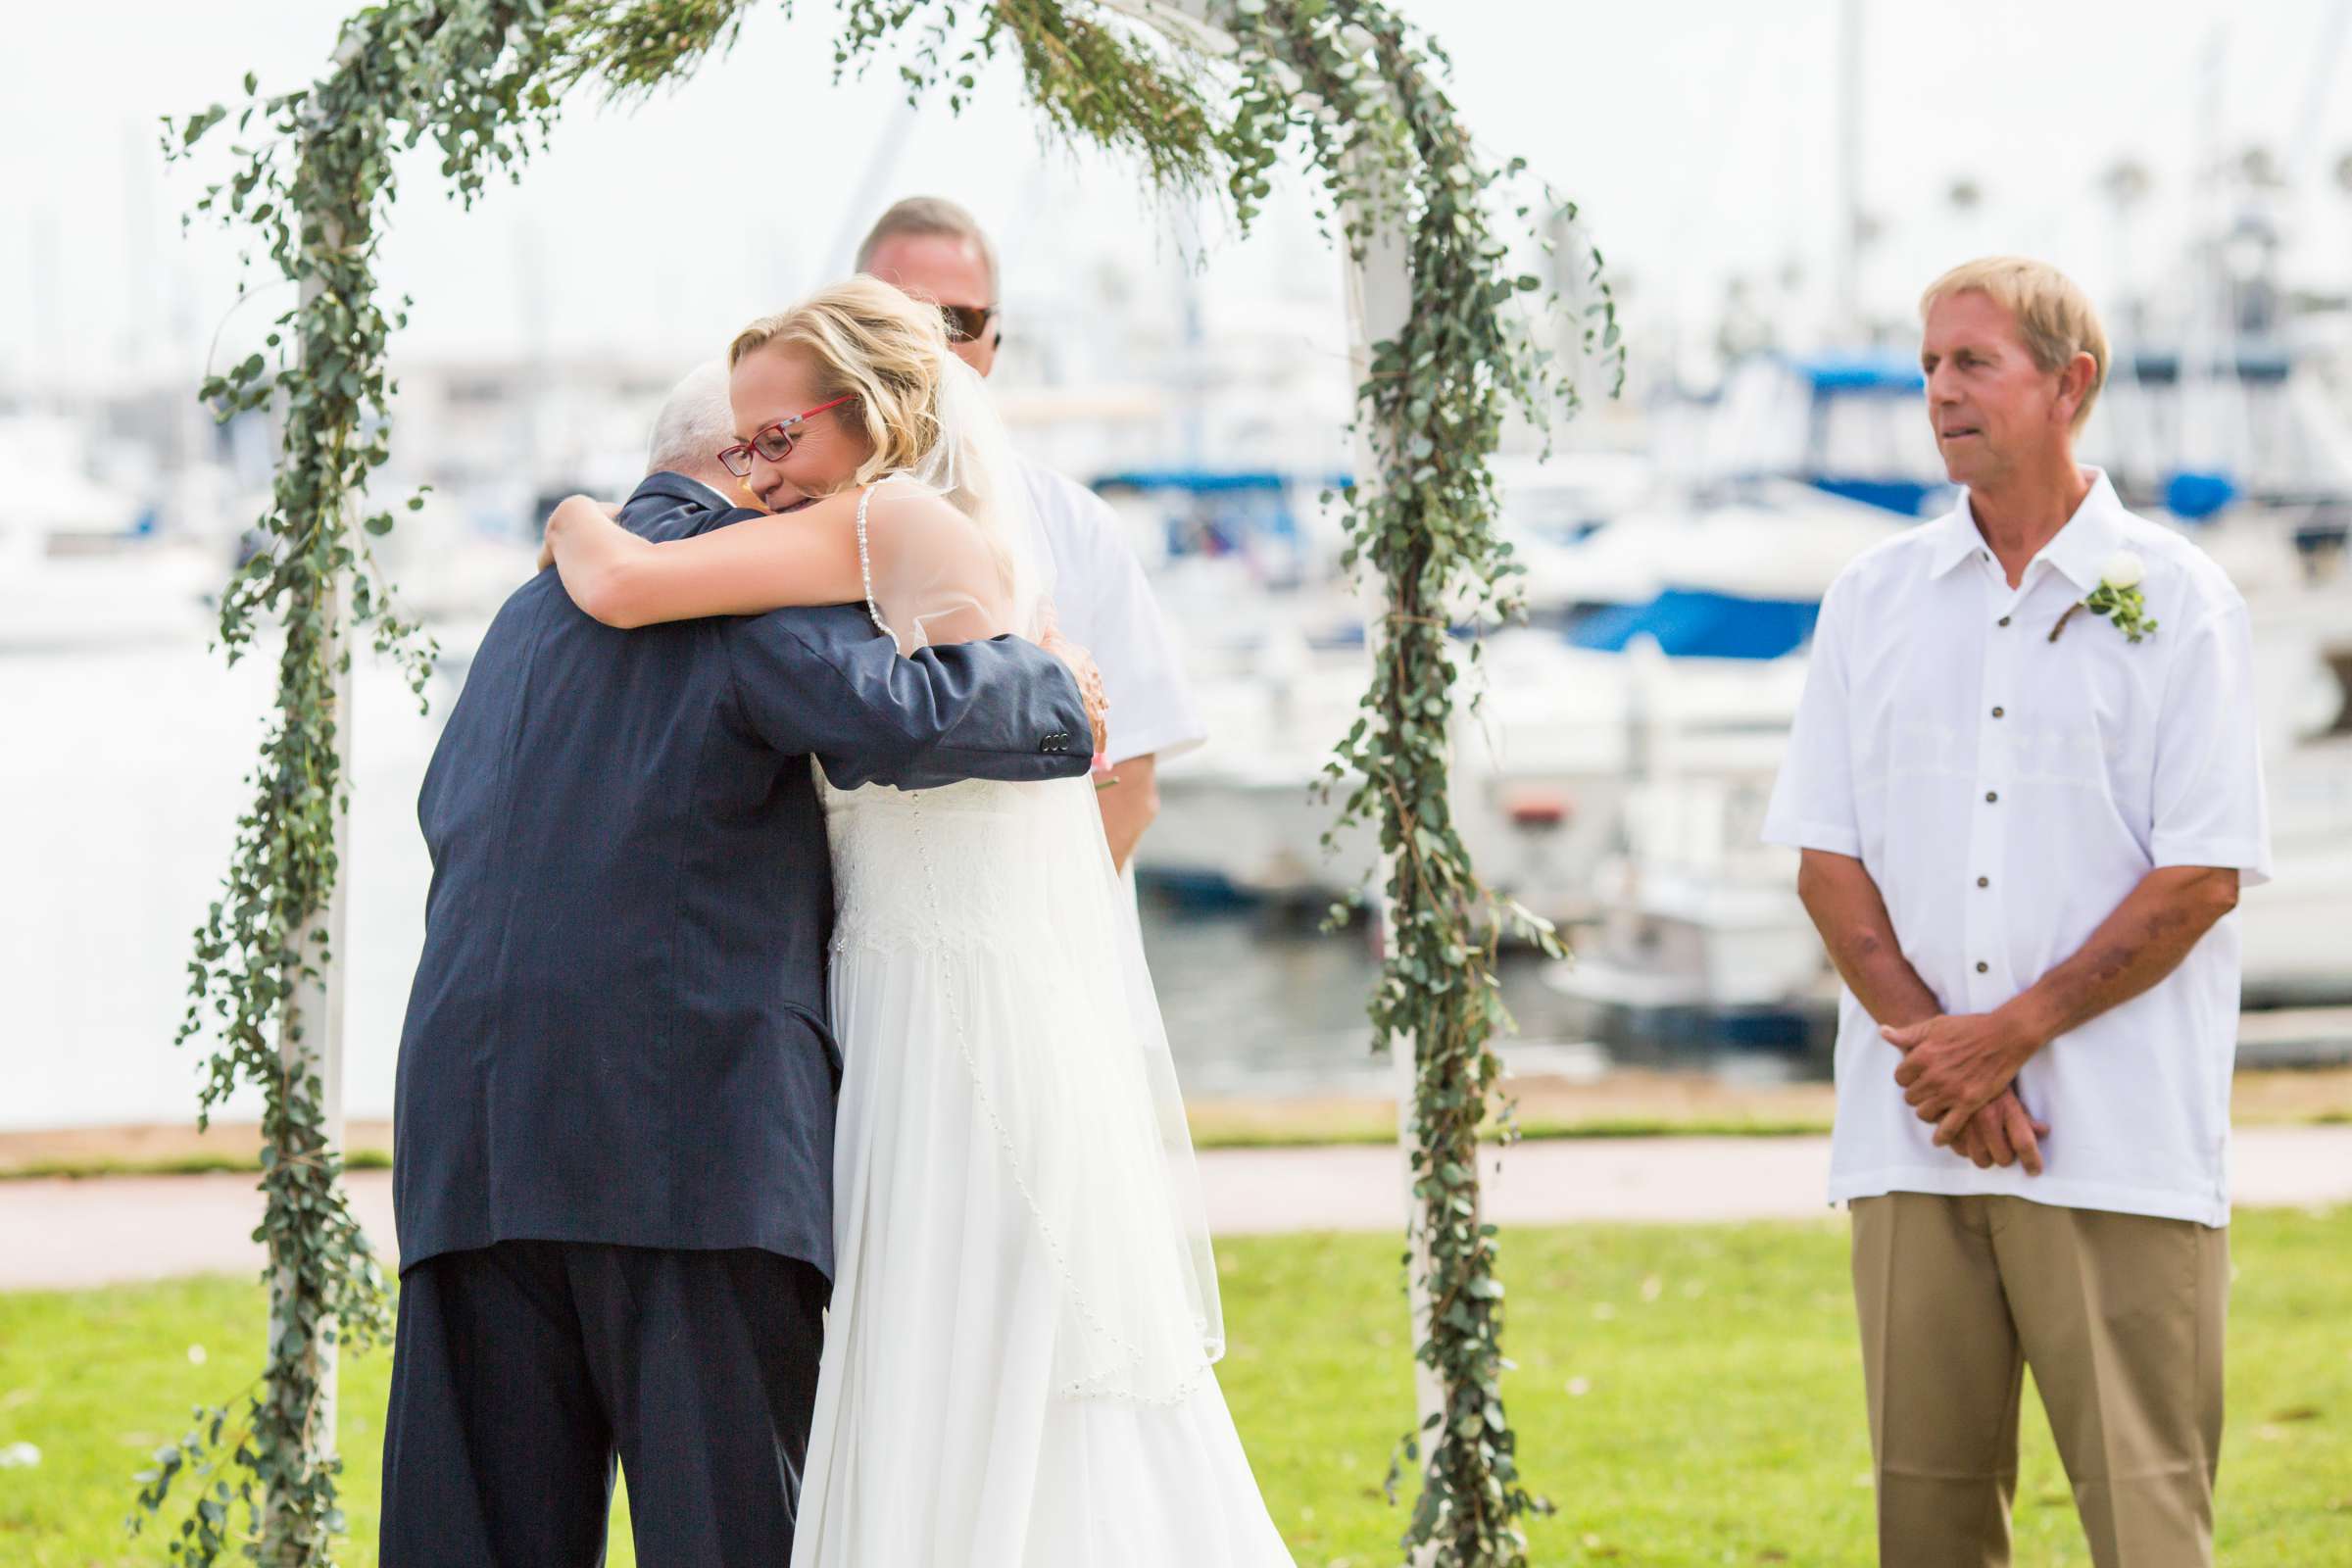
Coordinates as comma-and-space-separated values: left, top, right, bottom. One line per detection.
381, 367, 1092, 1568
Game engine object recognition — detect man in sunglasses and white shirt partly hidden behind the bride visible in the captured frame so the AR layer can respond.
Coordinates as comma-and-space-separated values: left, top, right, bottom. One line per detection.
858, 195, 1209, 870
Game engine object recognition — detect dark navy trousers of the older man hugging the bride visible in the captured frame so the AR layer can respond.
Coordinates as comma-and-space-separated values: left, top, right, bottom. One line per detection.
378, 1242, 830, 1568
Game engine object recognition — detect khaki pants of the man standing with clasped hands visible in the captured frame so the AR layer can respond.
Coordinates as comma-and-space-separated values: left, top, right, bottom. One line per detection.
1853, 1192, 2230, 1568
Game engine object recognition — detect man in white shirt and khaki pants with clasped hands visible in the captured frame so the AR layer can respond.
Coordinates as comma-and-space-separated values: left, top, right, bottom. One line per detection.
1764, 259, 2270, 1568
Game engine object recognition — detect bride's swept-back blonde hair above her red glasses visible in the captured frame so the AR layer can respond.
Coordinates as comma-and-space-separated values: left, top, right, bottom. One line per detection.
727, 277, 948, 487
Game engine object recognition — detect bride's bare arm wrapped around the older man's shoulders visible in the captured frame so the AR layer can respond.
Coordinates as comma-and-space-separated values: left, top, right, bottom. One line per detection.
543, 491, 865, 627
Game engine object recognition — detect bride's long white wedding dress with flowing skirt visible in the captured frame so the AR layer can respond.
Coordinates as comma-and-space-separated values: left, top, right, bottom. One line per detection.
793, 481, 1292, 1568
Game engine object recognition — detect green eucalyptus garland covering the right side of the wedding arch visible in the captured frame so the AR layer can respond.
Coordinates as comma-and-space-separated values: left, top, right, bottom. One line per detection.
1235, 0, 1623, 1568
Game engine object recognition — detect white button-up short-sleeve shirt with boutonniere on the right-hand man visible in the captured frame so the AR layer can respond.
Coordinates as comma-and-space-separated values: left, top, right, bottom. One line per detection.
1764, 472, 2270, 1225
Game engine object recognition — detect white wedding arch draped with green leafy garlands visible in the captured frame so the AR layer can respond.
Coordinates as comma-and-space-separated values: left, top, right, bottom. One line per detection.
147, 0, 1623, 1568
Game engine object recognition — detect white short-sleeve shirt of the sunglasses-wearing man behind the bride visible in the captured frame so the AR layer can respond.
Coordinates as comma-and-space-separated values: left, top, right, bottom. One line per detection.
1021, 461, 1209, 764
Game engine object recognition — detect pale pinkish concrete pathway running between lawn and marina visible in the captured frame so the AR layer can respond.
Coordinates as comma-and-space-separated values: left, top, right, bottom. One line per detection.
0, 1126, 2352, 1291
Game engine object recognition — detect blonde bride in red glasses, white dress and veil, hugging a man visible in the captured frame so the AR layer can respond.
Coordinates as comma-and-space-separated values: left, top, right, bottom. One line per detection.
548, 277, 1292, 1568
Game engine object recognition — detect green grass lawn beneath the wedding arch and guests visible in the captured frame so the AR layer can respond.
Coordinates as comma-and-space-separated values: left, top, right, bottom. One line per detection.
0, 1208, 2352, 1568
